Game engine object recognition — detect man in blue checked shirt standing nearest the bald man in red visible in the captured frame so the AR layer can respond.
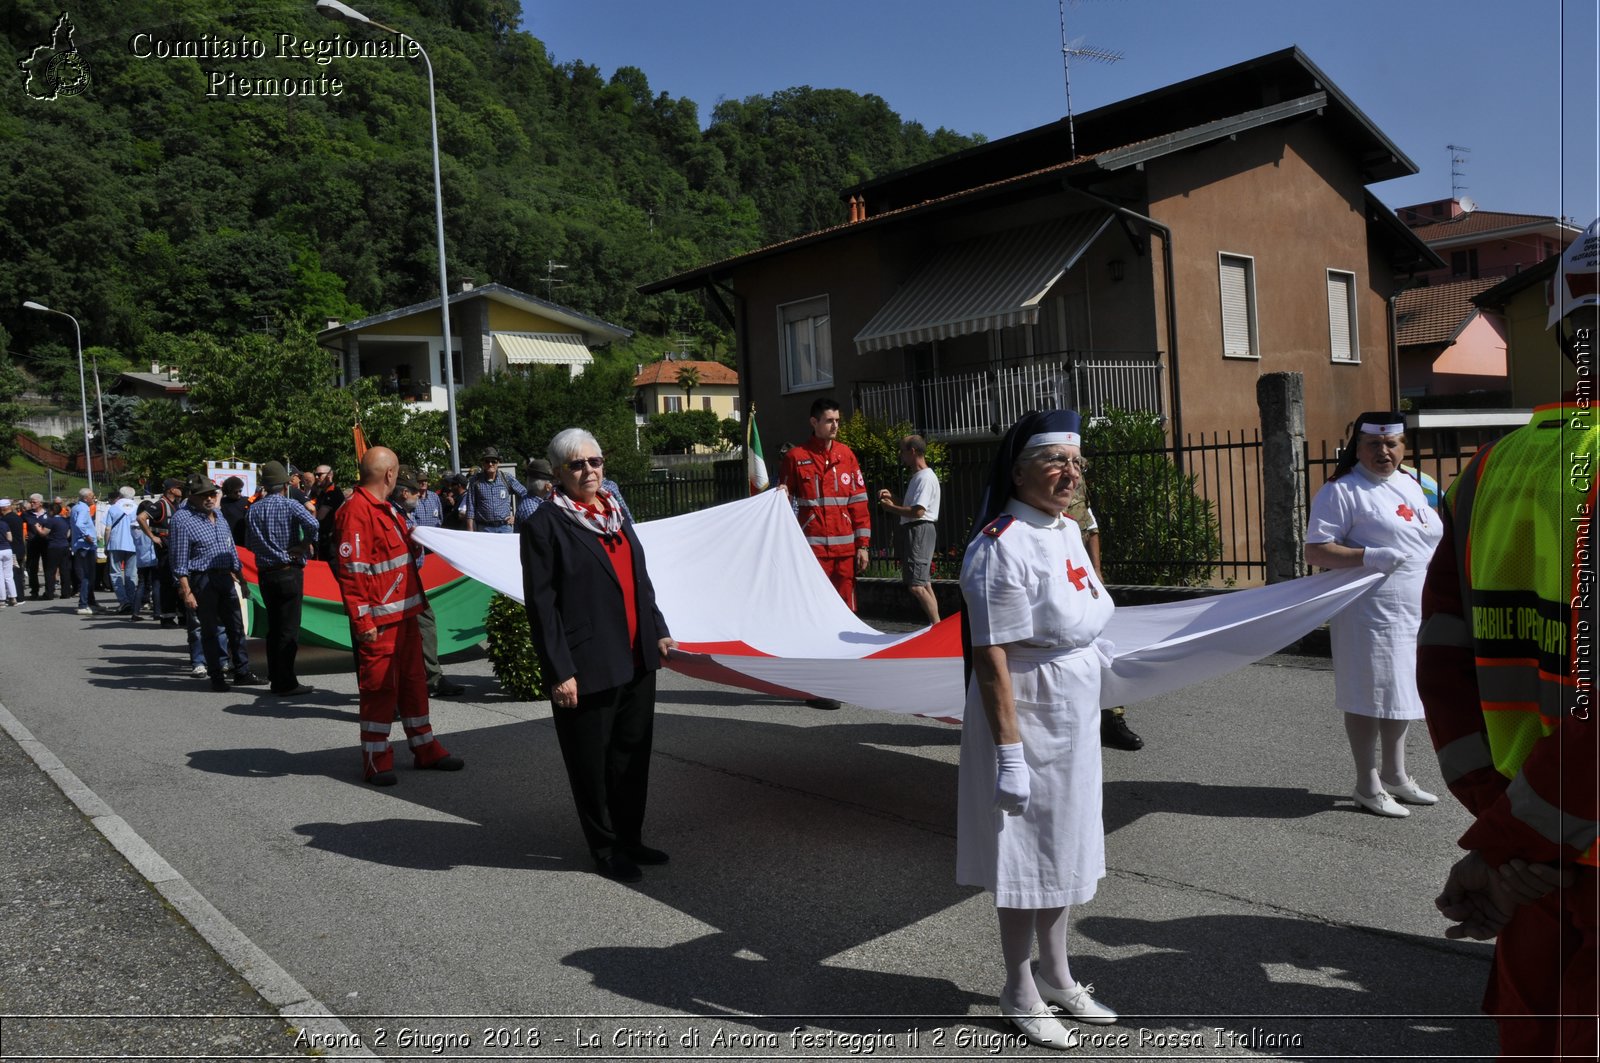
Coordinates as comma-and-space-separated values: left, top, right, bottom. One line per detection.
245, 461, 317, 698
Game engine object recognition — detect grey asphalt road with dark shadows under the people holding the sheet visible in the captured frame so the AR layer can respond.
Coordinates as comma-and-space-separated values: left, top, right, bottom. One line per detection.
0, 592, 1494, 1060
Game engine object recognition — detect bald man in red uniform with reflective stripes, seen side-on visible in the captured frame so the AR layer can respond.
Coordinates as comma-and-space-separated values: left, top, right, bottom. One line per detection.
331, 447, 461, 786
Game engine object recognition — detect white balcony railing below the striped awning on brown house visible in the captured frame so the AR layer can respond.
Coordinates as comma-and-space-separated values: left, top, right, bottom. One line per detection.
859, 352, 1166, 439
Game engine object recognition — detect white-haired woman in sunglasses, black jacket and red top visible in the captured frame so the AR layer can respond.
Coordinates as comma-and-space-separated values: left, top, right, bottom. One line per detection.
522, 427, 675, 882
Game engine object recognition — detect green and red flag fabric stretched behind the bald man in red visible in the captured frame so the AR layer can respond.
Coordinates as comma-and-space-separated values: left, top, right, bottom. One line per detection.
238, 547, 498, 656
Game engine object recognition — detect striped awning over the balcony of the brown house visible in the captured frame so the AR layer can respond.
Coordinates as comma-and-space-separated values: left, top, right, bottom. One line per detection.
856, 211, 1112, 354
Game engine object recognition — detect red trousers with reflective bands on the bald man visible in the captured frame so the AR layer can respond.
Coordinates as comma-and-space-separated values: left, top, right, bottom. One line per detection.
355, 616, 450, 778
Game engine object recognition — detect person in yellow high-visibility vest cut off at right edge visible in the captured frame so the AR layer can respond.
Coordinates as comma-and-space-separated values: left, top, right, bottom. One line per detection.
1418, 223, 1600, 1060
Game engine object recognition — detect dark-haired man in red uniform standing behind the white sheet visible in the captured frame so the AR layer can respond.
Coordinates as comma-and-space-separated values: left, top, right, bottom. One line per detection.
782, 397, 872, 709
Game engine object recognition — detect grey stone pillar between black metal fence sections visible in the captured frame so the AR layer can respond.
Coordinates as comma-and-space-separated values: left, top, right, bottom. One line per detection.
1256, 373, 1306, 583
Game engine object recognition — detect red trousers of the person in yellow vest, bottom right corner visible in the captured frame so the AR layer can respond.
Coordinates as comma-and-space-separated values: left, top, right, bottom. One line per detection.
1483, 868, 1600, 1060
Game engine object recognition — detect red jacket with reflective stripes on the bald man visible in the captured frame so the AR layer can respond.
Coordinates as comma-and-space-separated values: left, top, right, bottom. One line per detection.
331, 487, 427, 632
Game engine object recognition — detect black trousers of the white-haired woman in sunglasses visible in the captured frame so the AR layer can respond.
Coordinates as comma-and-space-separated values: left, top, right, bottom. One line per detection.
554, 669, 656, 856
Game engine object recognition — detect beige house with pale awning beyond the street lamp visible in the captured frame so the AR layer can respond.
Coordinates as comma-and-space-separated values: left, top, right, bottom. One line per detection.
317, 282, 632, 410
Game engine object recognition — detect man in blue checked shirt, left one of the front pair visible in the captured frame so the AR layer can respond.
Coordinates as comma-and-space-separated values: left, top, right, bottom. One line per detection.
171, 472, 261, 690
